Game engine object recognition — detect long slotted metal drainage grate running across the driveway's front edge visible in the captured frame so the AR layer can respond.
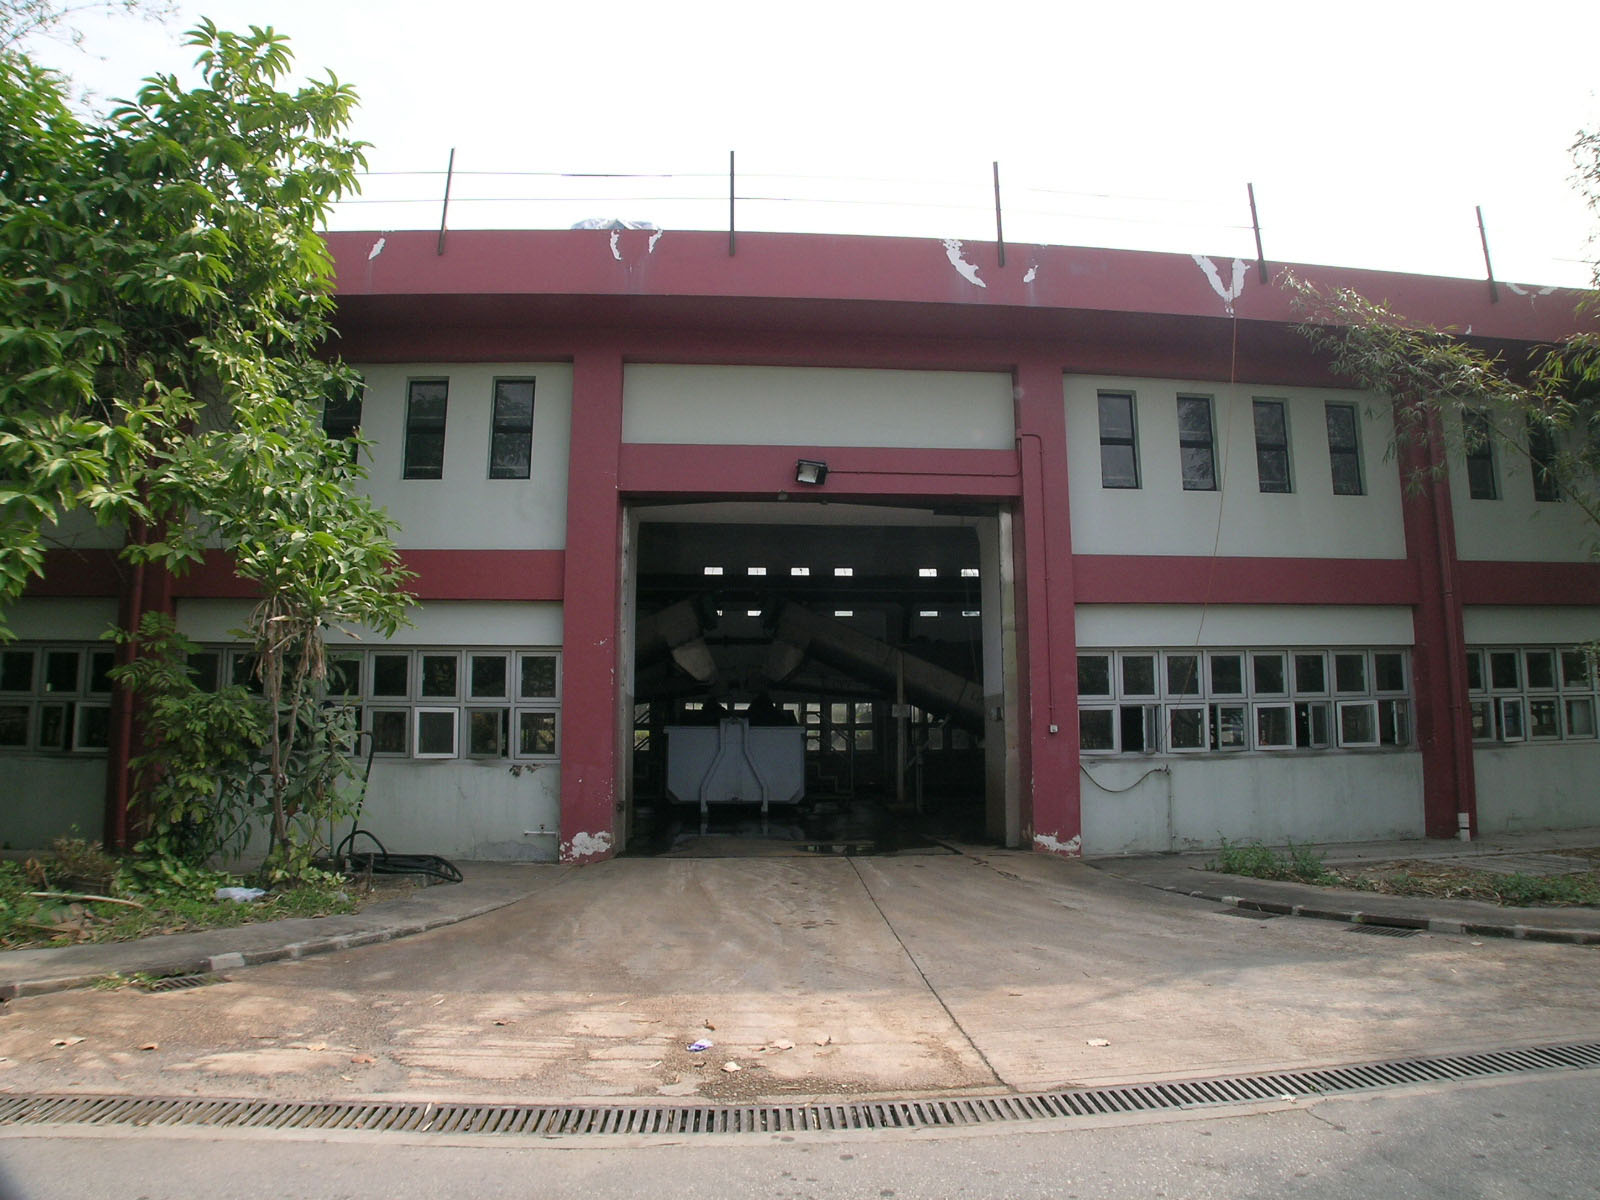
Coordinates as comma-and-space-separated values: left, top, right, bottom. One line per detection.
0, 1042, 1600, 1138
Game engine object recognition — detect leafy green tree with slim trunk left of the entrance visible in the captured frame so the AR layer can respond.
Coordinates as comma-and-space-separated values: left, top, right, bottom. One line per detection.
0, 22, 410, 876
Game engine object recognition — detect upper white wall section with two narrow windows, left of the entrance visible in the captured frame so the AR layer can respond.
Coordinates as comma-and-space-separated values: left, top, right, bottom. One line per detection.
358, 363, 573, 550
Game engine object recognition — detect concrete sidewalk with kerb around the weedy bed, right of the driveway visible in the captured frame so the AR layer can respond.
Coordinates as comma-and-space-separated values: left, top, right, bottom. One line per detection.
1085, 829, 1600, 946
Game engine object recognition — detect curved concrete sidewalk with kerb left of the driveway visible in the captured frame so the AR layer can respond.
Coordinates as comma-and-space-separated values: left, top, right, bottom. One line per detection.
0, 862, 573, 1000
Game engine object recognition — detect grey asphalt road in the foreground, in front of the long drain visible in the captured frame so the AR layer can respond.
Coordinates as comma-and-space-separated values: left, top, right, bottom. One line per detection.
0, 1072, 1600, 1200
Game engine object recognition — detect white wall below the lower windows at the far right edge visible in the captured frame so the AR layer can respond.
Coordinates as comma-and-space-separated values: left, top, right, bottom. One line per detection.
1472, 742, 1600, 834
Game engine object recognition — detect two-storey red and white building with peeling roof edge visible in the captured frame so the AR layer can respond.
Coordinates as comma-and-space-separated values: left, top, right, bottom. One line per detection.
0, 230, 1600, 861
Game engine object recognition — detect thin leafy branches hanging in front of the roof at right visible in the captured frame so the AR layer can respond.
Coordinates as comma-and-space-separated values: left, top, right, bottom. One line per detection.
1282, 131, 1600, 534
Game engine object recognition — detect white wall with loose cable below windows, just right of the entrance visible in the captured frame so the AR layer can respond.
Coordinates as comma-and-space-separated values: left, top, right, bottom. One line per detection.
1082, 750, 1424, 854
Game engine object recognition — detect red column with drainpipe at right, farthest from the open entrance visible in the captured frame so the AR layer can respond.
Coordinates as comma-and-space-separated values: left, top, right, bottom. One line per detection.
1398, 416, 1478, 837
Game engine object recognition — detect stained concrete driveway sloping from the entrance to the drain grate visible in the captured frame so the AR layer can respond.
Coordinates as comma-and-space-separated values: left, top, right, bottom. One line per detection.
0, 851, 1600, 1101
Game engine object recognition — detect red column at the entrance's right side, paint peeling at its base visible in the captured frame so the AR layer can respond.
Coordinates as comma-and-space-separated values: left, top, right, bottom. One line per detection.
1014, 360, 1083, 854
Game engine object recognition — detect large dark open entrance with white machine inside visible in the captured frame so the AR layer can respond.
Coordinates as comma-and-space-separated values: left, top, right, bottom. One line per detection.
621, 501, 1018, 853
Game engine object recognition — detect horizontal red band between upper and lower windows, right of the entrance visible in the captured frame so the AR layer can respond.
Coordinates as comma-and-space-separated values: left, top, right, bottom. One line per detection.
1074, 554, 1418, 605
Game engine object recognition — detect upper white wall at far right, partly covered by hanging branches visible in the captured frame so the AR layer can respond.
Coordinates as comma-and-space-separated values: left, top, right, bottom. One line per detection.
1448, 412, 1600, 563
